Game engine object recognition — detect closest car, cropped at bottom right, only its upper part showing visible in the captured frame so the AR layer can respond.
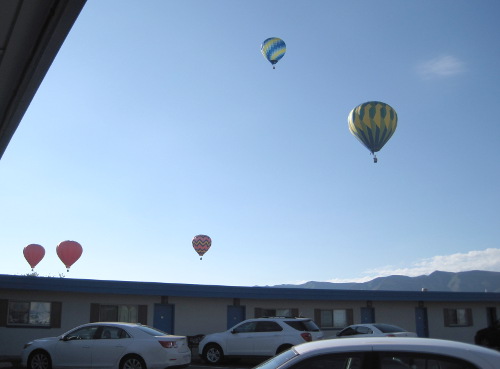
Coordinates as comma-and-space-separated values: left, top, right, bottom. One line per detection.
254, 337, 500, 369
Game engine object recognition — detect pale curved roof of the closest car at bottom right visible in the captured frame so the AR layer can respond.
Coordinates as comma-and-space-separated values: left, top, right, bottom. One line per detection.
294, 337, 500, 360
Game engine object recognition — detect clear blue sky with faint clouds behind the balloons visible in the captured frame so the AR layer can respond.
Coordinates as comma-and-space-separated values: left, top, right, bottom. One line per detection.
0, 0, 500, 286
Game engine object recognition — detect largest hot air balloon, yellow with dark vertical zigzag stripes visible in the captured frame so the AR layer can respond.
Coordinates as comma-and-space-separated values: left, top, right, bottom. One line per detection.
347, 101, 398, 163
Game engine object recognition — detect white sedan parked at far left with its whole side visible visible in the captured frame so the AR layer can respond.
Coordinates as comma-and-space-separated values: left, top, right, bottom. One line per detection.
22, 323, 191, 369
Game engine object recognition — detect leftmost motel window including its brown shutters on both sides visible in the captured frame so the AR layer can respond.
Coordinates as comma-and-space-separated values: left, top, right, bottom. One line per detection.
0, 300, 61, 328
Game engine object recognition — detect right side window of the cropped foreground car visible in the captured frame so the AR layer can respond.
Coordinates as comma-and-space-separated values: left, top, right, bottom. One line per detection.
380, 353, 477, 369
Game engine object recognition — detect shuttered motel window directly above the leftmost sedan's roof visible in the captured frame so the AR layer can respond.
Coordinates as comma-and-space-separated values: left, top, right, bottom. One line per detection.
90, 304, 148, 324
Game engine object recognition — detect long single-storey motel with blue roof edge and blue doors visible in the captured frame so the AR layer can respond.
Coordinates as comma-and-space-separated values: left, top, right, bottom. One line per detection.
0, 275, 500, 361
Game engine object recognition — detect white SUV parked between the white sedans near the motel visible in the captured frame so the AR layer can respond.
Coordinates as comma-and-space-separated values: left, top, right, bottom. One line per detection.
198, 318, 323, 364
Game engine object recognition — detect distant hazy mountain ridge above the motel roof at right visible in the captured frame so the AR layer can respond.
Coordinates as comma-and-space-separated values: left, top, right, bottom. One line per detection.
271, 270, 500, 292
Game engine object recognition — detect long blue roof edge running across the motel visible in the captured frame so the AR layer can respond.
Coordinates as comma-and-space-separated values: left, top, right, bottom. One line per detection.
0, 274, 500, 302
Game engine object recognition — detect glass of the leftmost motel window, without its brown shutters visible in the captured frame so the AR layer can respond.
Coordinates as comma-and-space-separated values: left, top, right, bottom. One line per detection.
7, 301, 51, 327
